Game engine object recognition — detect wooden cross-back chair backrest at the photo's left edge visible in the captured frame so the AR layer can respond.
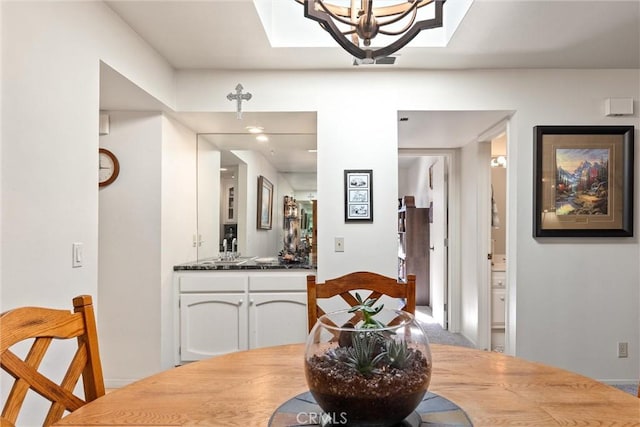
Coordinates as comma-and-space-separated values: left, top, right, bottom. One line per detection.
0, 295, 104, 427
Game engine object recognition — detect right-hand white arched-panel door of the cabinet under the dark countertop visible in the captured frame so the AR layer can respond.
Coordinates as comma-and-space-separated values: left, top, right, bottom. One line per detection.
249, 292, 308, 348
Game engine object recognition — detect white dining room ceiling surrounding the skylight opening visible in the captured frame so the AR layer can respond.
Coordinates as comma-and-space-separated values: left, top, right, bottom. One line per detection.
102, 0, 640, 70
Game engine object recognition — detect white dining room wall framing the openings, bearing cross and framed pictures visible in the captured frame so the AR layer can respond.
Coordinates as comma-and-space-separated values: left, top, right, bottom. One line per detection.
1, 2, 640, 404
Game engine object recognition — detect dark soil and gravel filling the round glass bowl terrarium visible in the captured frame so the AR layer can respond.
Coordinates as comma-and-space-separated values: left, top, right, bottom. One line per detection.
305, 348, 431, 425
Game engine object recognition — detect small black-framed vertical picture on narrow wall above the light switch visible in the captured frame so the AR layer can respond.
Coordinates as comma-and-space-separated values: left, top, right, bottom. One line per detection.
344, 169, 373, 222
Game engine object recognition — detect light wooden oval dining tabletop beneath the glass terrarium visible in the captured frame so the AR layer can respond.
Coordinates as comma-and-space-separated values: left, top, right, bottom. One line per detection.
56, 344, 640, 427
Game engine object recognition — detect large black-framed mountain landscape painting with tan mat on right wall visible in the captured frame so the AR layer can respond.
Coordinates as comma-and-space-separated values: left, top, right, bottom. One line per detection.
533, 126, 634, 237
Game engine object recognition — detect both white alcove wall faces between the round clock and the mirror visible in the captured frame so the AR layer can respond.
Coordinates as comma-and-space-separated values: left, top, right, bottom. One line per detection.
98, 111, 196, 387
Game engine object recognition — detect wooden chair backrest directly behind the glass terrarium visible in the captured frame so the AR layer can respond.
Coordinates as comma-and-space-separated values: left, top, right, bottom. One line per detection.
307, 271, 416, 331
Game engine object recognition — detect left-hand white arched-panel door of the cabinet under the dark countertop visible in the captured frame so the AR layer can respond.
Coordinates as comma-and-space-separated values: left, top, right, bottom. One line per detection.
180, 293, 248, 362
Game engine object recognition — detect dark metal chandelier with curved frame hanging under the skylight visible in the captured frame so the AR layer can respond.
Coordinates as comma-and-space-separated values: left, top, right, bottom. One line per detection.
295, 0, 446, 62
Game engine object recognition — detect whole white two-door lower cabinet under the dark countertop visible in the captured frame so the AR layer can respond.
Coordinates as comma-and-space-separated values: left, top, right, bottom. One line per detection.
174, 270, 310, 364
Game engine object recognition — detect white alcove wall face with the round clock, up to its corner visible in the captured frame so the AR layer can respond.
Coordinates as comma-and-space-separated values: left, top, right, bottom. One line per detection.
98, 112, 162, 386
